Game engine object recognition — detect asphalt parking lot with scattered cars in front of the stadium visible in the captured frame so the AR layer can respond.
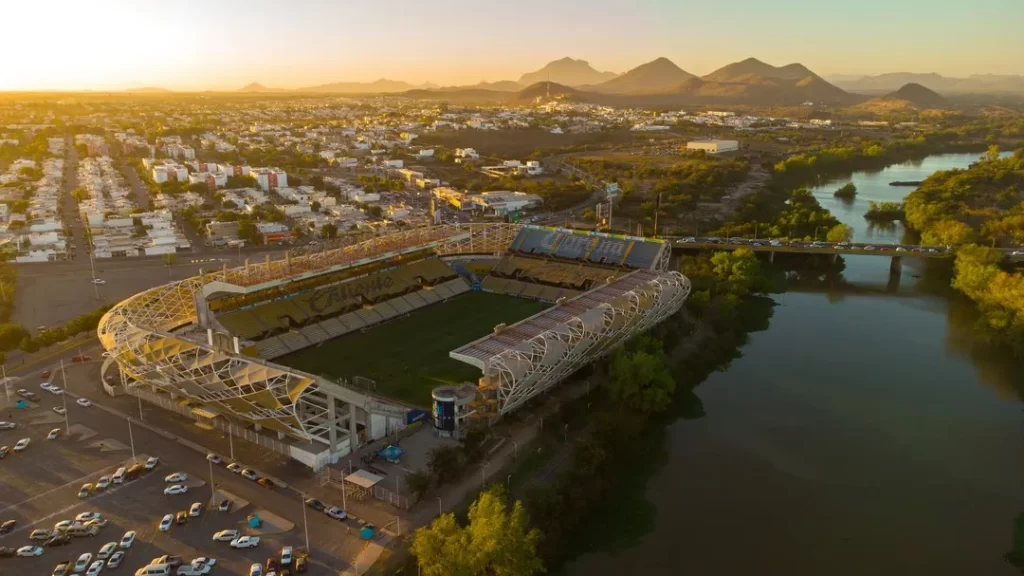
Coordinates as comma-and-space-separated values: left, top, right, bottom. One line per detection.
0, 368, 361, 576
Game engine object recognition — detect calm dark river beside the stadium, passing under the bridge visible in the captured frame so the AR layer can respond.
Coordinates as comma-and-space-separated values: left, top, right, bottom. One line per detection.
567, 150, 1024, 576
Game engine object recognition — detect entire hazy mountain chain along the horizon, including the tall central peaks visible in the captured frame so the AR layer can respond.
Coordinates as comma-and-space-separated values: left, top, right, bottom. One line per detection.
117, 57, 1024, 109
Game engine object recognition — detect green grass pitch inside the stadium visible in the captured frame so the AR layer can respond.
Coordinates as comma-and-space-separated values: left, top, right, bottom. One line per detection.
274, 292, 545, 407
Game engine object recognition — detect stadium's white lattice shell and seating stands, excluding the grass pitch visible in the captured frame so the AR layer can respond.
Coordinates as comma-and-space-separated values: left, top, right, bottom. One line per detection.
97, 223, 689, 468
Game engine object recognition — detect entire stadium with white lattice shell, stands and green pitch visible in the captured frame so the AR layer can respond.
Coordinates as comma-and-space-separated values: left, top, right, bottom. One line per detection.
97, 223, 690, 469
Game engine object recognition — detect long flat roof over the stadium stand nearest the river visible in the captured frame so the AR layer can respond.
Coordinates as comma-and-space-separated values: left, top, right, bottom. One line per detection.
450, 270, 659, 370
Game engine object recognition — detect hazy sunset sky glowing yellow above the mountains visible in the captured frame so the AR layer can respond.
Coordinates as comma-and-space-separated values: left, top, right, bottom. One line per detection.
0, 0, 1024, 90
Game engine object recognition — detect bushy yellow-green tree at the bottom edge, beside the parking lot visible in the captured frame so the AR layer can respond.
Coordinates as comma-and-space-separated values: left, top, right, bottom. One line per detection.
412, 486, 544, 576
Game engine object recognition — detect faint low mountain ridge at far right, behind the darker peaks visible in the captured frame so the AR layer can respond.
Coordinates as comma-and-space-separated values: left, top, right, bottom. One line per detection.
831, 72, 1024, 94
